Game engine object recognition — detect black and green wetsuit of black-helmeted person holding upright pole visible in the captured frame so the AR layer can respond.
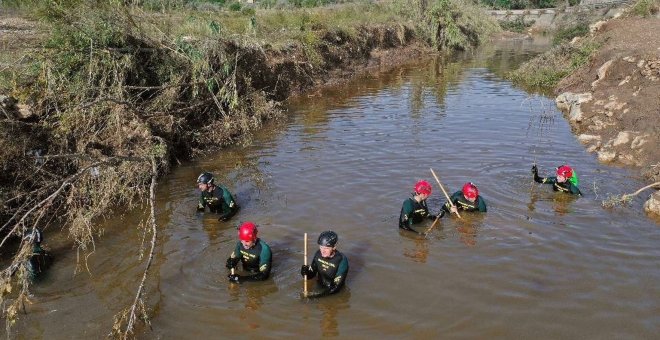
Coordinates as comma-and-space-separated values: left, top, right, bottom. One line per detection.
307, 250, 348, 297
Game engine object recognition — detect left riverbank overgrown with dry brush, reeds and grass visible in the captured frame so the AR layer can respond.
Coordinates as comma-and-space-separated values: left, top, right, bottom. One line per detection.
0, 1, 497, 332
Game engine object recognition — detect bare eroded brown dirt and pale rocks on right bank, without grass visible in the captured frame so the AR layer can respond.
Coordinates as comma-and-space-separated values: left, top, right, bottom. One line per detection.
556, 17, 660, 212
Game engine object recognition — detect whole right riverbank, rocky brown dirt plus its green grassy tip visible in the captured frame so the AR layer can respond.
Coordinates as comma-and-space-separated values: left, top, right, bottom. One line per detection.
512, 1, 660, 214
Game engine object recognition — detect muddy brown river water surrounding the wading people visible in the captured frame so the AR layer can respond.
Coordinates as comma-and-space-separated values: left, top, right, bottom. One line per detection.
12, 38, 660, 339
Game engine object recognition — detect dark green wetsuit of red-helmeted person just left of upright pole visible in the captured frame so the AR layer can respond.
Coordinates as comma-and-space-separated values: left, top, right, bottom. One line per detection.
230, 239, 273, 281
